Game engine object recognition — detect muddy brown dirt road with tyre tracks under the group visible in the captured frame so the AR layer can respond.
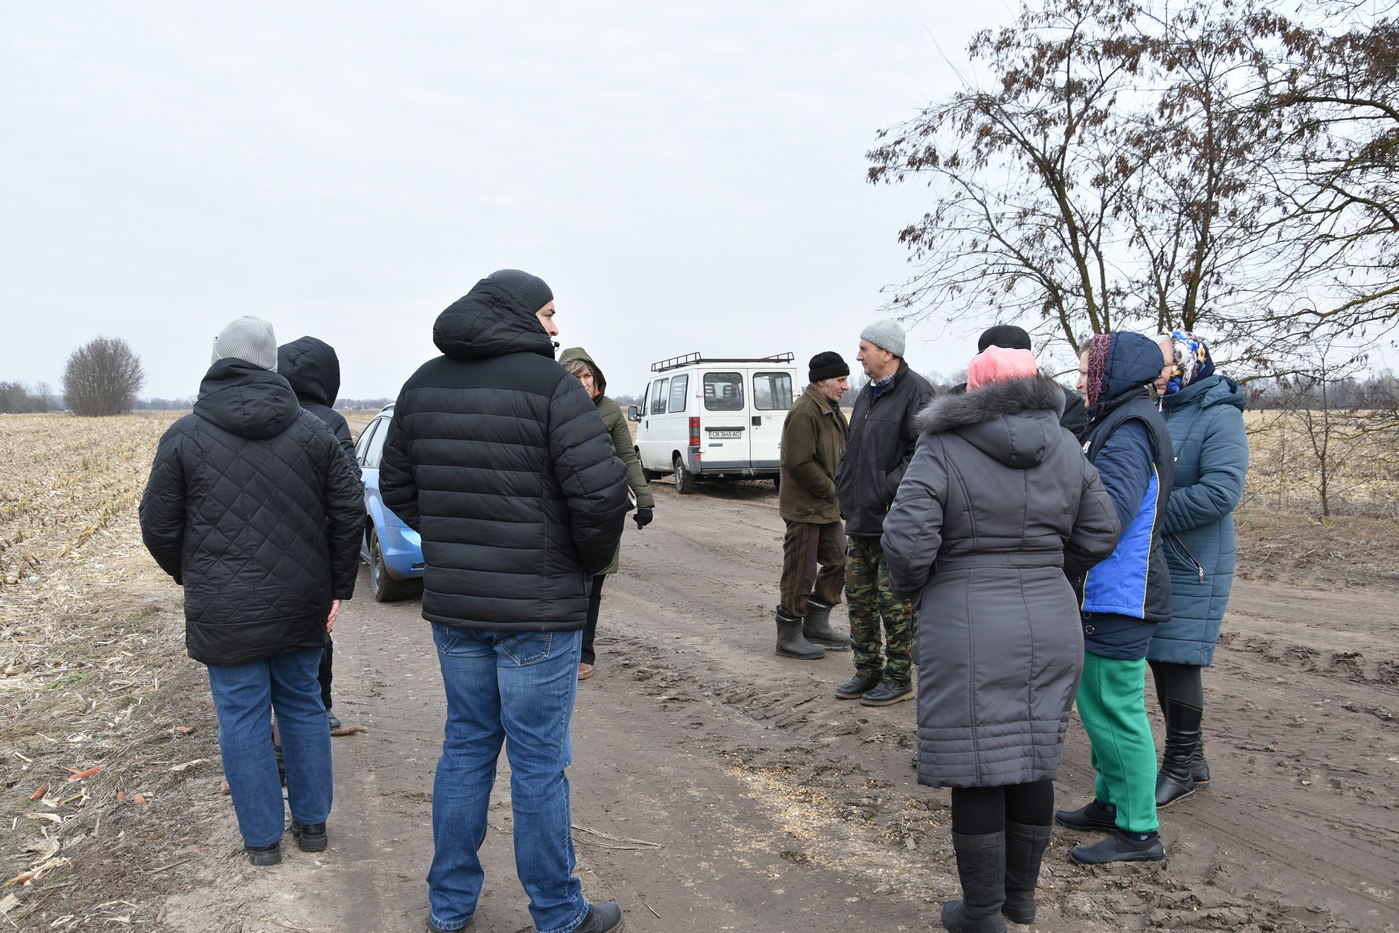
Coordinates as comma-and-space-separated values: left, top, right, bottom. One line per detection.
147, 483, 1399, 933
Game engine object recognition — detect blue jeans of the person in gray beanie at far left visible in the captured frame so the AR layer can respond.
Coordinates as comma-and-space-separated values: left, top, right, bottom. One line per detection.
208, 648, 333, 846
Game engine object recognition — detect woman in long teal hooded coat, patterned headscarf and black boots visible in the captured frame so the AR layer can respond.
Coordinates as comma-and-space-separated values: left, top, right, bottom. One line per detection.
1146, 330, 1248, 809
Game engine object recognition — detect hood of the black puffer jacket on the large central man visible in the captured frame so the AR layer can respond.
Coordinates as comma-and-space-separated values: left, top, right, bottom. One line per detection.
432, 278, 554, 359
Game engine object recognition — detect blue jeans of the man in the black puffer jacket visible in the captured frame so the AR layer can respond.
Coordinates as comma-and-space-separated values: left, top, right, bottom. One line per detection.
428, 625, 588, 933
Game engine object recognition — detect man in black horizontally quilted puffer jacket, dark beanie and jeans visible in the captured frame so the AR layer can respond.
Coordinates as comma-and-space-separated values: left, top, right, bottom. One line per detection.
379, 270, 628, 933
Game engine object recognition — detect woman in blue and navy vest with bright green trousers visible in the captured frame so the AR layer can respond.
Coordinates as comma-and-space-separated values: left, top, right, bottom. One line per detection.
1055, 332, 1175, 864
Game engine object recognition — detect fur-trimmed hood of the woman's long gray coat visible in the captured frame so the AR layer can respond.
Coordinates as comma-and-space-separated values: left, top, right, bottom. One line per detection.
915, 366, 1063, 470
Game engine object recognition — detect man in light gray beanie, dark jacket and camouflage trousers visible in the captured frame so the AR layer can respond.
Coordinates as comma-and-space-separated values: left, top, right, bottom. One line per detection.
835, 320, 933, 706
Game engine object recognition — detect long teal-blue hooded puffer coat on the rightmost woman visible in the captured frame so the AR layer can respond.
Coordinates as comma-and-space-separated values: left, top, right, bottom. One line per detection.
1147, 375, 1248, 667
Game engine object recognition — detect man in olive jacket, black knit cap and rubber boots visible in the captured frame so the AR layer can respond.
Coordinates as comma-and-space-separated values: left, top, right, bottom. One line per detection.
776, 350, 851, 660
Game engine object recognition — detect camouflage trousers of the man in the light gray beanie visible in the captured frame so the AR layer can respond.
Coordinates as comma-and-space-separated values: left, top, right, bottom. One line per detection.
845, 534, 914, 684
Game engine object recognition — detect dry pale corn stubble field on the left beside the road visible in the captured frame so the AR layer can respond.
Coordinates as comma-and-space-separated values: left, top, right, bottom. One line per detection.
0, 411, 218, 929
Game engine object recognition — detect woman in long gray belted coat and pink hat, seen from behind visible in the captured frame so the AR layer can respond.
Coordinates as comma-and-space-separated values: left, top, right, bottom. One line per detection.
883, 347, 1119, 933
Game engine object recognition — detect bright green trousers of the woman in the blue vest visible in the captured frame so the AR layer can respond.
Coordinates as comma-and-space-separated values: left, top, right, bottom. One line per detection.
1077, 653, 1160, 832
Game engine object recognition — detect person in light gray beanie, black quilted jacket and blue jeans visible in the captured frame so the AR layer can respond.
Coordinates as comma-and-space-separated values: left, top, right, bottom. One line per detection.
140, 316, 364, 864
